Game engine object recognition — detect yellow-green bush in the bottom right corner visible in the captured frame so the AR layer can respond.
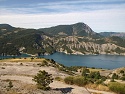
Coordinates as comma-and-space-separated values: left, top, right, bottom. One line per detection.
109, 82, 125, 94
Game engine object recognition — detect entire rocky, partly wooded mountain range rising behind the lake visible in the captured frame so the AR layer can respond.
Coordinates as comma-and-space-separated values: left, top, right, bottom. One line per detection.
0, 23, 125, 56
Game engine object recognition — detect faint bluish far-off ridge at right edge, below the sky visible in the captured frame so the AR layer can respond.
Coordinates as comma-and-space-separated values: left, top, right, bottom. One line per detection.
99, 32, 125, 37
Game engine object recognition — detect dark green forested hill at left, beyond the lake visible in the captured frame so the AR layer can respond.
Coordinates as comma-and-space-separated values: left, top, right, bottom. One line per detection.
0, 25, 55, 56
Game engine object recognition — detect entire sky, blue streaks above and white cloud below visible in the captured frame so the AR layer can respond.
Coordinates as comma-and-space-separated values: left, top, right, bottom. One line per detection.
0, 0, 125, 32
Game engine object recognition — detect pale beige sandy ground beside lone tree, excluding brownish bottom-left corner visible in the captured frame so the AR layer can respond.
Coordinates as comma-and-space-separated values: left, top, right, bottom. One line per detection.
0, 62, 114, 94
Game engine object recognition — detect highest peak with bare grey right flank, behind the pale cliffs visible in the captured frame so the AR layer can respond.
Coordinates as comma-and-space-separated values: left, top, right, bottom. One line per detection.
39, 23, 100, 37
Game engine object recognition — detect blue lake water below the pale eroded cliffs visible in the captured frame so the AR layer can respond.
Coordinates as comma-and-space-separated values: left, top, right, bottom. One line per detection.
0, 53, 125, 69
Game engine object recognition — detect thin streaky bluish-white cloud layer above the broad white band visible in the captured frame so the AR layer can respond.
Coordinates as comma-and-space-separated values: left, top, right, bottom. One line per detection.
0, 0, 125, 14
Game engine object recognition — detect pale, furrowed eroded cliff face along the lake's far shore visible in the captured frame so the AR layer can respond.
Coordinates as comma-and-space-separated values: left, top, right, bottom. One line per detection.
56, 36, 125, 55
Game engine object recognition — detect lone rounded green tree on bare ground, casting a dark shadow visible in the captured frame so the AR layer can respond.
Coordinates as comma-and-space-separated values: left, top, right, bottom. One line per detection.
33, 70, 53, 90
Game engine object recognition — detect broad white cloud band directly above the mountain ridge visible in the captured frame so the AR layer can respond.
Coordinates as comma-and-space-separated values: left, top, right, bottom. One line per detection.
0, 9, 125, 32
